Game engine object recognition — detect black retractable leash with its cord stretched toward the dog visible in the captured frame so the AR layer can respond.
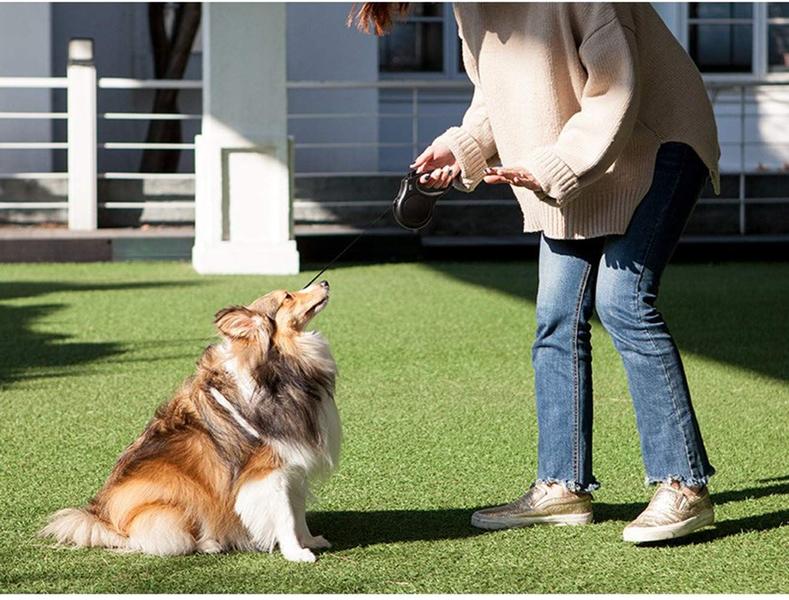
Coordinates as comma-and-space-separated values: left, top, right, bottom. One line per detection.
304, 171, 449, 288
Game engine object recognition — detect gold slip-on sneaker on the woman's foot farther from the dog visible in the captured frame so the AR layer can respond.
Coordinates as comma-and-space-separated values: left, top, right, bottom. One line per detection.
622, 483, 715, 544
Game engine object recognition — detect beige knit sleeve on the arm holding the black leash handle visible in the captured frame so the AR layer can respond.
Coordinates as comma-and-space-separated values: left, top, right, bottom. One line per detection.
433, 41, 497, 192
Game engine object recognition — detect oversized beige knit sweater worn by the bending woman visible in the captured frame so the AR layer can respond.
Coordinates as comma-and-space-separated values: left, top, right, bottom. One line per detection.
436, 2, 720, 239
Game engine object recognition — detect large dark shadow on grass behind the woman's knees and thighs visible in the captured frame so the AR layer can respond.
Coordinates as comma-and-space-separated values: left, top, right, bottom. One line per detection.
427, 262, 789, 381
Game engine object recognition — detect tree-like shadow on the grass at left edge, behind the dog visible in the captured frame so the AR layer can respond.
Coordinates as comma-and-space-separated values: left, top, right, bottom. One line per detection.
0, 281, 192, 387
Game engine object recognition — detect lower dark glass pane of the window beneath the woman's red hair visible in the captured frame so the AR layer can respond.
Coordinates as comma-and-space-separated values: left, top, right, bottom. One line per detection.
378, 22, 444, 73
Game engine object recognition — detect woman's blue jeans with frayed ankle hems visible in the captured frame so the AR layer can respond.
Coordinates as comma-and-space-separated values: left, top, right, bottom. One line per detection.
532, 142, 715, 491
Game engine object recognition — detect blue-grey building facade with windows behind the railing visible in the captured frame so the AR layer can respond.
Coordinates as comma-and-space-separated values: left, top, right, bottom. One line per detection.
0, 2, 789, 240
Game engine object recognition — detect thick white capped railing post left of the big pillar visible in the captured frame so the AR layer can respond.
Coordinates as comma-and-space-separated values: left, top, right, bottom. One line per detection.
66, 38, 98, 230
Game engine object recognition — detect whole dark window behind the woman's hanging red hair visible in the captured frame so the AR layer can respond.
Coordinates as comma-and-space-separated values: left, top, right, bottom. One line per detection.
378, 2, 444, 73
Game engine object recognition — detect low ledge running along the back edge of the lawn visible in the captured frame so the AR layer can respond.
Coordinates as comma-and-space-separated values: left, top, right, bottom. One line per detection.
0, 225, 789, 262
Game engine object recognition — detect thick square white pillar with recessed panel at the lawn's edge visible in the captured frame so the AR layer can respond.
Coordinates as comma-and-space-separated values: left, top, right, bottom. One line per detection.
192, 2, 299, 274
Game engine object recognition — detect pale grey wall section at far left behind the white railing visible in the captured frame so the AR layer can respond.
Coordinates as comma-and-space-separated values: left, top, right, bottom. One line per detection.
0, 2, 51, 173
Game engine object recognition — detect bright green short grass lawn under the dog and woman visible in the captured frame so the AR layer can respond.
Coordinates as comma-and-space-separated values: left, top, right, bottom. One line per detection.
0, 263, 789, 593
